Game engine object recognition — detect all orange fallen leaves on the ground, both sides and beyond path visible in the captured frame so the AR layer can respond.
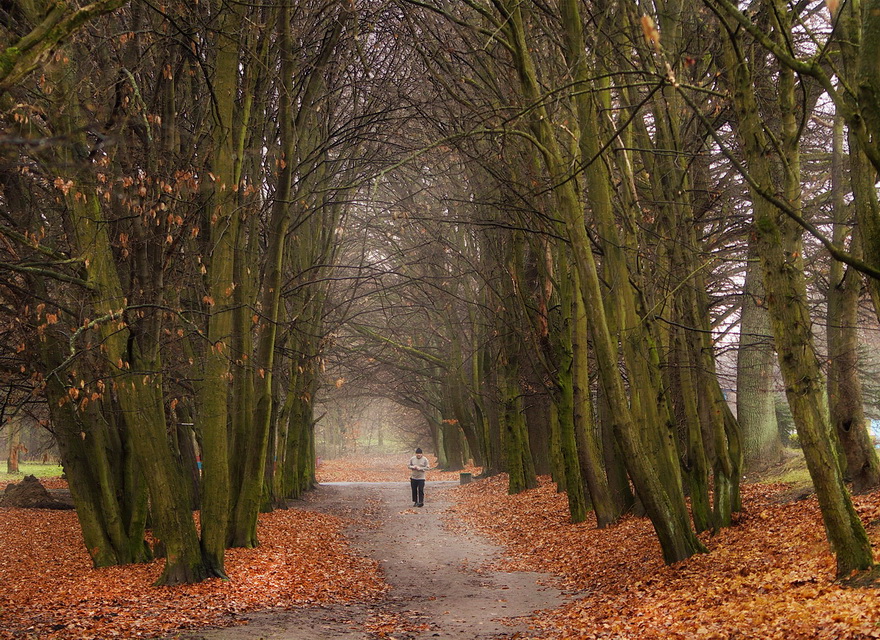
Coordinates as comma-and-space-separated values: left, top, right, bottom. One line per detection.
0, 455, 880, 640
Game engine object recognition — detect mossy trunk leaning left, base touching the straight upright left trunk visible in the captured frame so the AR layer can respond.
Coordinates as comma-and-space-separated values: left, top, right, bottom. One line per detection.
43, 41, 206, 584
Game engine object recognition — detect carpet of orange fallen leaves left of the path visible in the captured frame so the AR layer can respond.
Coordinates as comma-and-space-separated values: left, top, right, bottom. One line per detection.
0, 500, 386, 640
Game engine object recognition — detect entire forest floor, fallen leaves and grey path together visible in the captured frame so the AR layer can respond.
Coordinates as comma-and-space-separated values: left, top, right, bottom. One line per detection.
0, 456, 880, 640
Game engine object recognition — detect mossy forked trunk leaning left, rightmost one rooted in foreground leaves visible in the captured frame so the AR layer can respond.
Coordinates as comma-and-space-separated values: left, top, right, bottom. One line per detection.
725, 21, 873, 577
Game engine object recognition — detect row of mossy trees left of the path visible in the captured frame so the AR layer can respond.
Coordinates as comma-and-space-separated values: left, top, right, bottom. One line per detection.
0, 1, 402, 584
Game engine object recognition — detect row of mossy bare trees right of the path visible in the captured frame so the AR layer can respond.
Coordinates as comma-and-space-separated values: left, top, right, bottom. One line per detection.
320, 0, 878, 575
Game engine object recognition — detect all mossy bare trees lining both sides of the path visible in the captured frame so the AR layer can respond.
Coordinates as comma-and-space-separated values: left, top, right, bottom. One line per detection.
0, 0, 880, 584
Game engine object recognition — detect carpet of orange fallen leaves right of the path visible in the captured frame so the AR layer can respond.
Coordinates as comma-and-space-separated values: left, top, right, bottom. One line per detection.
450, 476, 880, 640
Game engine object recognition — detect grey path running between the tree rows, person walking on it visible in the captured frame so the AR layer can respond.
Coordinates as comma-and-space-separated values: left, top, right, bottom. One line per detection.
181, 482, 562, 640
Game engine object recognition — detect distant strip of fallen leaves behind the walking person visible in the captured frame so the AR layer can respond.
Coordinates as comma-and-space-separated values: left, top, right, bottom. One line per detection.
317, 453, 481, 482
